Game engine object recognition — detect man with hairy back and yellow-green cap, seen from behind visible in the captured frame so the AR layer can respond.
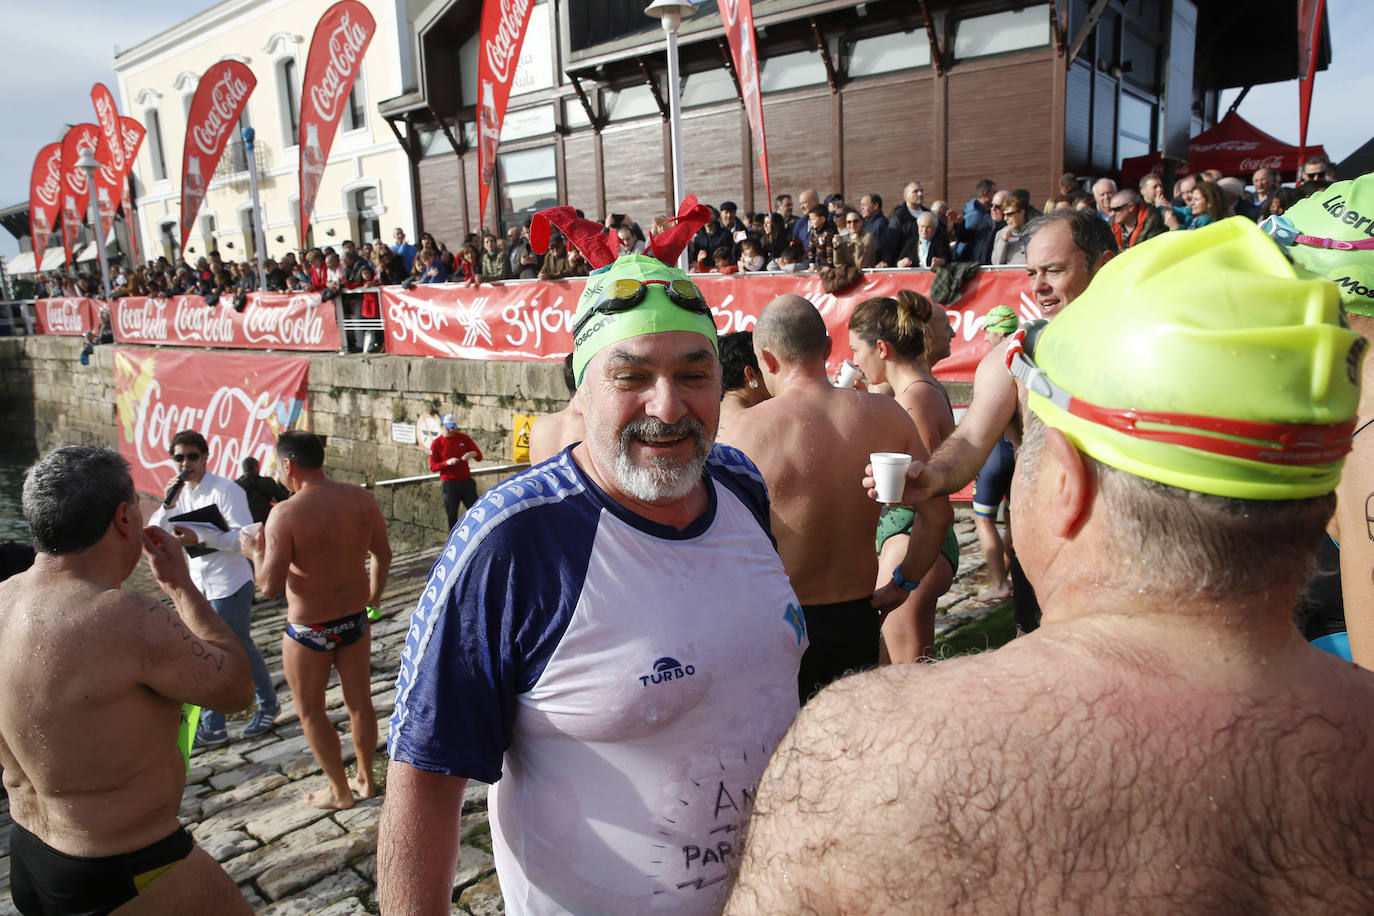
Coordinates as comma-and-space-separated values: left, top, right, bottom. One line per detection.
727, 218, 1374, 915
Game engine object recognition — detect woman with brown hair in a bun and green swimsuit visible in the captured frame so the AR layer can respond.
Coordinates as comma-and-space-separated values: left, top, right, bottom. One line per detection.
849, 290, 959, 663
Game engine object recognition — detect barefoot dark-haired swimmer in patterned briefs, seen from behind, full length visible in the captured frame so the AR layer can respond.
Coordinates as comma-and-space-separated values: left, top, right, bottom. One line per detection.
242, 430, 392, 808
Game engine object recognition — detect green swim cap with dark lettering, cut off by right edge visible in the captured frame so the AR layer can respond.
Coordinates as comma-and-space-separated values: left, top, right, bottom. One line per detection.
1279, 173, 1374, 317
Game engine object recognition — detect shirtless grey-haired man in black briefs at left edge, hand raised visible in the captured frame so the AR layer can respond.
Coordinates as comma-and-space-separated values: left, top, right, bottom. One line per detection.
0, 445, 253, 916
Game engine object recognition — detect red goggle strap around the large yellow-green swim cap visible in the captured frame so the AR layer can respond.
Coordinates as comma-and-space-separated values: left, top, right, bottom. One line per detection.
1007, 319, 1355, 464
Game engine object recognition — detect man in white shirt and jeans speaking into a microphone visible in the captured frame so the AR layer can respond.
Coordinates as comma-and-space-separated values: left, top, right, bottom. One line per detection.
148, 430, 280, 747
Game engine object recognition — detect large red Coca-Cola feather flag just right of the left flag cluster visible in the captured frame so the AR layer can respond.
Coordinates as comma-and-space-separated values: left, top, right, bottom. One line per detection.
181, 60, 257, 251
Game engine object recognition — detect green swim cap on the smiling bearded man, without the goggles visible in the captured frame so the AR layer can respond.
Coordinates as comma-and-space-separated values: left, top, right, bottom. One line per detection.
573, 254, 720, 385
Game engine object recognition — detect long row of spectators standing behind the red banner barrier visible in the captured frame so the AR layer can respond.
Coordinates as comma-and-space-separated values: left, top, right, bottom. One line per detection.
34, 149, 1336, 307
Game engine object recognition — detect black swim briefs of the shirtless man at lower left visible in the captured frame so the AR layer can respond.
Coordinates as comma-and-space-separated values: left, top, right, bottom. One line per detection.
10, 824, 195, 916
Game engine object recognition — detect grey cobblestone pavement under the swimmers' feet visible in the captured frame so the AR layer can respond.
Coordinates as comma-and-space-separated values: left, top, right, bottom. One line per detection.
0, 509, 1011, 916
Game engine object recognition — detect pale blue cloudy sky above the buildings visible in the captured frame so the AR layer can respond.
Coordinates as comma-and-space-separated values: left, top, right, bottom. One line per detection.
0, 0, 1374, 263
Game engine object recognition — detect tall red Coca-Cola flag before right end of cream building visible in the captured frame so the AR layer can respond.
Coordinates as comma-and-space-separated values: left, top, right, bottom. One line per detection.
298, 0, 376, 249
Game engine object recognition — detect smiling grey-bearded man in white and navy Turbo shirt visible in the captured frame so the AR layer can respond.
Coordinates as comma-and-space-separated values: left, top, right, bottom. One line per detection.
378, 247, 802, 913
